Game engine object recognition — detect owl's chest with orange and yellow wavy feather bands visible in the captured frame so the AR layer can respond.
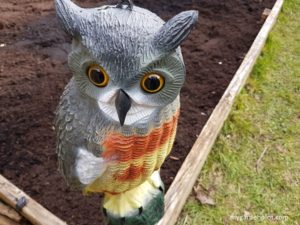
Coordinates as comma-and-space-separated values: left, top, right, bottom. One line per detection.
89, 111, 179, 193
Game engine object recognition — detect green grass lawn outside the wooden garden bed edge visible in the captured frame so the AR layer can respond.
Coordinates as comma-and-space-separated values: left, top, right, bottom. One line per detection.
177, 0, 300, 225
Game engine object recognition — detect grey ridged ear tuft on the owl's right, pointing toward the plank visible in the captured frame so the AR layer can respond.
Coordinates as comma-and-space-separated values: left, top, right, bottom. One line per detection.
153, 10, 198, 52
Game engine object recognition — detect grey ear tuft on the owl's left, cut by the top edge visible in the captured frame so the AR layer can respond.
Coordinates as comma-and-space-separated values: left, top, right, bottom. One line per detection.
55, 0, 84, 37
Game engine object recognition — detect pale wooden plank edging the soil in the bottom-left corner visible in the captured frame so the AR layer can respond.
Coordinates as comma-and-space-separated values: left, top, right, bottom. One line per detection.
0, 175, 66, 225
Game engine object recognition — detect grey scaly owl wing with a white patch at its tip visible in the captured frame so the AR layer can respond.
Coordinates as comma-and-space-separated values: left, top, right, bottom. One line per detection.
55, 80, 107, 189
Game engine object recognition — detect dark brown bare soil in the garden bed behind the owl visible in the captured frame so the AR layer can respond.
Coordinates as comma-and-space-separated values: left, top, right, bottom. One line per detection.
0, 0, 275, 225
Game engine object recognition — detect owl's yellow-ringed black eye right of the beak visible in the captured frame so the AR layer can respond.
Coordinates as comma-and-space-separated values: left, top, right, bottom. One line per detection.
141, 73, 165, 93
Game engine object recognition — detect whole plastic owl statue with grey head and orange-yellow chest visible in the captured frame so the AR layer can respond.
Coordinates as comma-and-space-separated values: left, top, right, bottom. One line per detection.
55, 0, 198, 225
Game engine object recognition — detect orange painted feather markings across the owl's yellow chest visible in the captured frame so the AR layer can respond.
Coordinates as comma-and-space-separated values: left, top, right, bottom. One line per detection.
102, 110, 179, 182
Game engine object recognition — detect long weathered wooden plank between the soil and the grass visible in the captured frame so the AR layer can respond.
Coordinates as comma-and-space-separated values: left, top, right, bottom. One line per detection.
157, 0, 284, 225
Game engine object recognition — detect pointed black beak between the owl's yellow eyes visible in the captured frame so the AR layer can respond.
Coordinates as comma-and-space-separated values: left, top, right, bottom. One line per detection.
115, 89, 131, 126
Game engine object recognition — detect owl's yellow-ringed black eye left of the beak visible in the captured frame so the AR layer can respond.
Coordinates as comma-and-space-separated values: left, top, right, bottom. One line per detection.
87, 65, 109, 87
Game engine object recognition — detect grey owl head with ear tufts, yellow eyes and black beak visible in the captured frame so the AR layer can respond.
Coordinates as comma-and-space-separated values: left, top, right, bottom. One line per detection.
55, 0, 198, 126
